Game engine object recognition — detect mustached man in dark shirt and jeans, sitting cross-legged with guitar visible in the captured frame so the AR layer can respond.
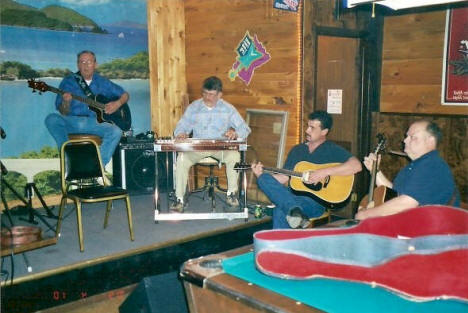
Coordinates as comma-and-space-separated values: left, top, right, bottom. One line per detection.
252, 111, 362, 228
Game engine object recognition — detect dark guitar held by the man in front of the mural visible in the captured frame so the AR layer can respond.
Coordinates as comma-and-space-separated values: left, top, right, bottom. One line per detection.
28, 79, 132, 131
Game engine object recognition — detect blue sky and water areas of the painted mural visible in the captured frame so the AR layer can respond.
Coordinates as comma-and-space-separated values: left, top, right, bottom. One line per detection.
0, 0, 151, 158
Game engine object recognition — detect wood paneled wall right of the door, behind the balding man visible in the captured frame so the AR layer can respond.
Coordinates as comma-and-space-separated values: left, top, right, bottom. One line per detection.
378, 9, 468, 202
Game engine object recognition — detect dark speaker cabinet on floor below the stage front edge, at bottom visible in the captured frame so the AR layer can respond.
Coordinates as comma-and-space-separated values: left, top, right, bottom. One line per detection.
119, 272, 188, 313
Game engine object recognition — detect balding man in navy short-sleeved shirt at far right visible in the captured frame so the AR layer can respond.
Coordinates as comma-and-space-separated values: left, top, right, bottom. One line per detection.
355, 120, 460, 220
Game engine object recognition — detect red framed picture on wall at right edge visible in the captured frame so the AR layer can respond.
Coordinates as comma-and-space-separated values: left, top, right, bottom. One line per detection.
441, 8, 468, 105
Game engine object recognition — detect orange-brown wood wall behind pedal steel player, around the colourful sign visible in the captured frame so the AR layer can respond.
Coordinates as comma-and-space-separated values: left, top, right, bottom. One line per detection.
185, 0, 301, 156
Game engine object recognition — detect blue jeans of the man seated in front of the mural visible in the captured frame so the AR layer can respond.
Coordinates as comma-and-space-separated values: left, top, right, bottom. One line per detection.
45, 113, 122, 165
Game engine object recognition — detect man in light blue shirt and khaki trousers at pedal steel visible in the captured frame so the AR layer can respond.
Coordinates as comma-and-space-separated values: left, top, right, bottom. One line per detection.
171, 76, 250, 212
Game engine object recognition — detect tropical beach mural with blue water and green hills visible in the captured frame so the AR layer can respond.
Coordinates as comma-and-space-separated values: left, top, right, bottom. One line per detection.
0, 0, 151, 199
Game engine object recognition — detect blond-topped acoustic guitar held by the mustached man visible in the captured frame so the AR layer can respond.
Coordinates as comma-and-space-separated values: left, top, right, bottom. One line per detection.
234, 161, 354, 203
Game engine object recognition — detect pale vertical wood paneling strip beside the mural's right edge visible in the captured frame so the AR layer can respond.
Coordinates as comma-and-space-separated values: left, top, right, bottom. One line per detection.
147, 0, 188, 136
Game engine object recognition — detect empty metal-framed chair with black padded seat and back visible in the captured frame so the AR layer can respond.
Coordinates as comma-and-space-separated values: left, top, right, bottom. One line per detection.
56, 139, 134, 252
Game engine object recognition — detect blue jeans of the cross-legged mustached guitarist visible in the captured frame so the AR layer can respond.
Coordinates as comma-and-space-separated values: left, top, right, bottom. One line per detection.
257, 173, 325, 228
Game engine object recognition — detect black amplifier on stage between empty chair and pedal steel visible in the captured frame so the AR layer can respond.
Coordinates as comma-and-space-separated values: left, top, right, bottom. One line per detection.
112, 142, 173, 194
